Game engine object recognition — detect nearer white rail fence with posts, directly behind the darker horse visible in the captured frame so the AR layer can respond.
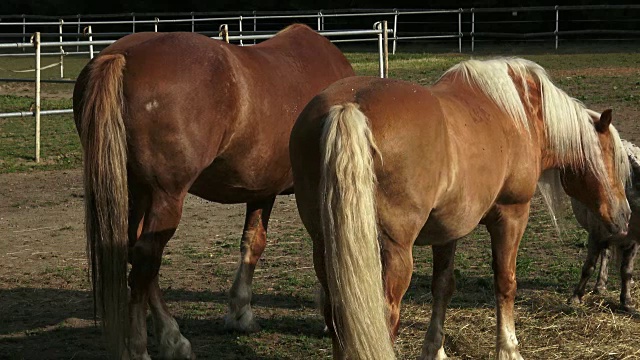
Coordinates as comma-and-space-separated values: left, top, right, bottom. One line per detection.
0, 21, 390, 162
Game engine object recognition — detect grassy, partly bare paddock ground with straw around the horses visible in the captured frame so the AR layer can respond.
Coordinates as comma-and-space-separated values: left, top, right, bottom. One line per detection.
0, 46, 640, 359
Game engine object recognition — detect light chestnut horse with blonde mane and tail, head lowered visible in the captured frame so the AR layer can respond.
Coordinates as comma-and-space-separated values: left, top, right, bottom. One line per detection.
289, 59, 629, 360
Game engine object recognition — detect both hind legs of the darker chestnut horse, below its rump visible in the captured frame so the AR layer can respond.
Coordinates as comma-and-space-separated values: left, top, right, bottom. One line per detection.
129, 192, 194, 359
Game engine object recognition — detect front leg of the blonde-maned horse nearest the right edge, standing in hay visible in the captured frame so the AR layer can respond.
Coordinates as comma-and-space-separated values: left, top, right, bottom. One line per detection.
485, 203, 529, 360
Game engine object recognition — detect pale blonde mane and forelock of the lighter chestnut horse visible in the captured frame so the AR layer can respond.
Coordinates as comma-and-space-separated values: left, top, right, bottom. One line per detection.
438, 58, 630, 227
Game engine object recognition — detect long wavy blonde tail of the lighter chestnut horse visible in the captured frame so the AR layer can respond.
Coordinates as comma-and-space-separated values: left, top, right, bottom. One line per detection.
320, 103, 395, 360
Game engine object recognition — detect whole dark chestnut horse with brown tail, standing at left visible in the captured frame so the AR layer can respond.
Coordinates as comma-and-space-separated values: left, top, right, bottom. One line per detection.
74, 25, 354, 359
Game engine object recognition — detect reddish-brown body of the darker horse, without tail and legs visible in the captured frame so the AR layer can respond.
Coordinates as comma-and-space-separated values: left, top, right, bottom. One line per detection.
74, 26, 353, 202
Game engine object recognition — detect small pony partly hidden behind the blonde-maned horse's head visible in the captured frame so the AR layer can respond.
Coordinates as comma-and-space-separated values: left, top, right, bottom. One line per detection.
569, 140, 640, 311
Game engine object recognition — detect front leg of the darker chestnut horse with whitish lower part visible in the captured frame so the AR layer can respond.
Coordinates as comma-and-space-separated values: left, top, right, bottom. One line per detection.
224, 197, 275, 332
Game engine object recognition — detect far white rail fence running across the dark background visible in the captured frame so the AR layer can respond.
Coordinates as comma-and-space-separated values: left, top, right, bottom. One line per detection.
0, 4, 640, 55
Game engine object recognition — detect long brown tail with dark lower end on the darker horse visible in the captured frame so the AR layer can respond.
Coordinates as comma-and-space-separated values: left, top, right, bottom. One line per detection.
78, 54, 129, 359
